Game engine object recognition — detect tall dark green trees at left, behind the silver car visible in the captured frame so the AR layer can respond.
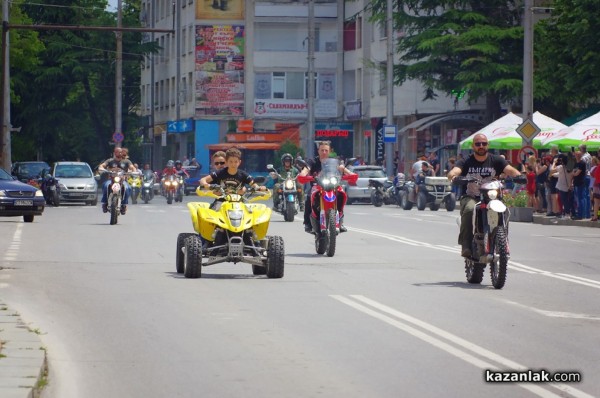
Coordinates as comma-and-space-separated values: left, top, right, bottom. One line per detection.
13, 0, 153, 163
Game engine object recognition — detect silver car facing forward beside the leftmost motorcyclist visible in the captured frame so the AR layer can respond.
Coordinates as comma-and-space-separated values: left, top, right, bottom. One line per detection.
52, 162, 98, 206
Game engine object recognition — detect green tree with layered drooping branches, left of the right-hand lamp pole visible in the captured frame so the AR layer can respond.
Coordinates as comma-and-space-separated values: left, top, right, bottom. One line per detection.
371, 0, 523, 120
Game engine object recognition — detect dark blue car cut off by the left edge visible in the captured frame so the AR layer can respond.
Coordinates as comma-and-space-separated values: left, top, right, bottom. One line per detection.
0, 169, 46, 222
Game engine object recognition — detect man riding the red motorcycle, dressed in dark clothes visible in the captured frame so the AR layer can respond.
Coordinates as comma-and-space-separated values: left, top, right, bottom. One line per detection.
299, 141, 354, 234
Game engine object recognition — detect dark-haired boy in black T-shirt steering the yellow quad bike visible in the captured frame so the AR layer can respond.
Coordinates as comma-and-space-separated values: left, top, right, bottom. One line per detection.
198, 148, 267, 210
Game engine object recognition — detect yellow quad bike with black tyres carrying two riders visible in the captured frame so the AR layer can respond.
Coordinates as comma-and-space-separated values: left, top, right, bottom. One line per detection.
175, 185, 285, 278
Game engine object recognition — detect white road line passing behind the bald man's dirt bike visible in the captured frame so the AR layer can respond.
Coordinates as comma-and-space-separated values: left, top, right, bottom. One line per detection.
347, 227, 600, 289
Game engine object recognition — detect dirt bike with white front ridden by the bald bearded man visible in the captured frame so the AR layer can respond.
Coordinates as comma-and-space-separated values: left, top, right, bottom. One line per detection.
453, 176, 527, 289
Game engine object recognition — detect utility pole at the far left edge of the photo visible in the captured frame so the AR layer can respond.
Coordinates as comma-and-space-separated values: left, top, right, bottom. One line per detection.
0, 0, 12, 171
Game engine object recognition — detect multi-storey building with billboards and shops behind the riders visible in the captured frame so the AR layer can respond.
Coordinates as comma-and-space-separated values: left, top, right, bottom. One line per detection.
141, 0, 488, 172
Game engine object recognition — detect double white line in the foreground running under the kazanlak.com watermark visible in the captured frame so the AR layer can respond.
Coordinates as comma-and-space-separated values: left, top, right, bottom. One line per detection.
331, 295, 592, 398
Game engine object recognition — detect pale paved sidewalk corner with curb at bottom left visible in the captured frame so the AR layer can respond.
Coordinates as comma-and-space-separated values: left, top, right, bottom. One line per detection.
0, 301, 47, 398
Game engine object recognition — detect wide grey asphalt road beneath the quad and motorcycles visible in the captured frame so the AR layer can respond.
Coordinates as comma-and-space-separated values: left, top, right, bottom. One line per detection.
0, 197, 600, 398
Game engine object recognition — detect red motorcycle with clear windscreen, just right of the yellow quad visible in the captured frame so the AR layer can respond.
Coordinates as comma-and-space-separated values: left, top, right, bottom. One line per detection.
298, 158, 358, 257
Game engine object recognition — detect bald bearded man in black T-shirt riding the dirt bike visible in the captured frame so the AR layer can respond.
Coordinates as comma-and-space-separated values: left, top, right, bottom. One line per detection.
448, 134, 521, 258
